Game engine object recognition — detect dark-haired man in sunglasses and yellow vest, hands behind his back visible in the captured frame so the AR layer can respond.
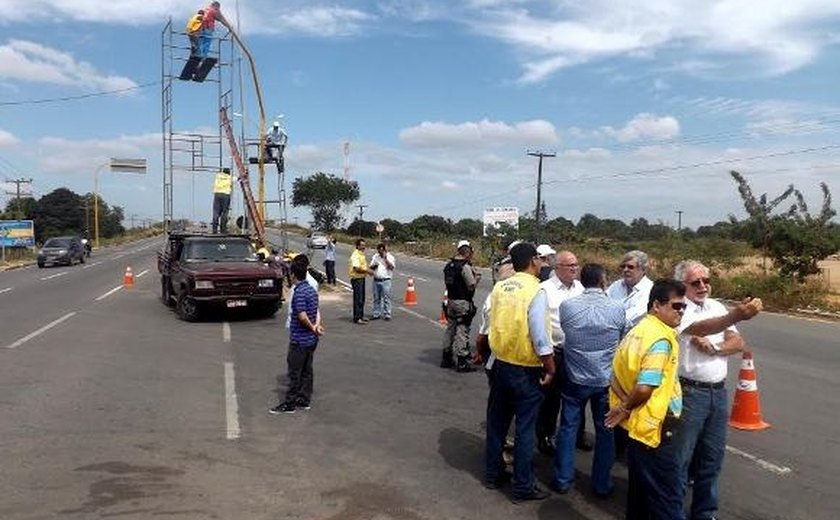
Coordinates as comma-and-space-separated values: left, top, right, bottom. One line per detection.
605, 279, 686, 520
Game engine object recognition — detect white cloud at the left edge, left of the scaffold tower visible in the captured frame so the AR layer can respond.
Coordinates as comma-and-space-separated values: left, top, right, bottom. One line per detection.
0, 40, 137, 90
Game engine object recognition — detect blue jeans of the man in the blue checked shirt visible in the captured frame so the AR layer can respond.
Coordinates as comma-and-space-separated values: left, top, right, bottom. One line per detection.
554, 380, 615, 495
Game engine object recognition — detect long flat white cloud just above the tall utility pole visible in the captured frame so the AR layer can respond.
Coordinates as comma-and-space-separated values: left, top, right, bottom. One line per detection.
400, 119, 560, 148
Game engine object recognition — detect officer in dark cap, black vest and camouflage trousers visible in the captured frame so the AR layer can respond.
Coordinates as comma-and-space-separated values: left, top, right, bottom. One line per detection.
440, 240, 481, 372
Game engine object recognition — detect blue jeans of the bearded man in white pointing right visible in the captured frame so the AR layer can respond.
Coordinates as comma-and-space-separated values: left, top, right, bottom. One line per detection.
674, 385, 729, 520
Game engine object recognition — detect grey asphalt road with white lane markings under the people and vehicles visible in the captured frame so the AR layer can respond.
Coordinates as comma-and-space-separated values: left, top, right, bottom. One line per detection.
0, 233, 840, 520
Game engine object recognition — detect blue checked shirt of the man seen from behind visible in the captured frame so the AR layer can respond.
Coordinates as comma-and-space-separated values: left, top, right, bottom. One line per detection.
560, 288, 629, 387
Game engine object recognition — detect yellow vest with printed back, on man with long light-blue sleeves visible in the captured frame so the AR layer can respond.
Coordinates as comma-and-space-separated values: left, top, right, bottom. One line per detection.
490, 272, 551, 367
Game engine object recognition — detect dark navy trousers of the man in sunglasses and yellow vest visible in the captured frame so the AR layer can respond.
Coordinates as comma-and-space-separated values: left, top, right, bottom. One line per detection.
625, 418, 685, 520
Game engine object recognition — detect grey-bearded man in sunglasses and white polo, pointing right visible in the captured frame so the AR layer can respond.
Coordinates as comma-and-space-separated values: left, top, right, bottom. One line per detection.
674, 260, 761, 520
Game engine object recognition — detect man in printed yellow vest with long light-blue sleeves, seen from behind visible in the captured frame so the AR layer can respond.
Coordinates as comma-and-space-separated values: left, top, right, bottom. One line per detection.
484, 242, 555, 503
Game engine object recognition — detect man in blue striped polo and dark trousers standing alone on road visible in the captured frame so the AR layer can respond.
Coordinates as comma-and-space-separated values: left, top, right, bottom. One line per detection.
269, 262, 324, 415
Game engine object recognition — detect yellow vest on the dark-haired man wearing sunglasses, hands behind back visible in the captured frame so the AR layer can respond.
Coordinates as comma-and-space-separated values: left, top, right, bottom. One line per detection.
610, 314, 682, 448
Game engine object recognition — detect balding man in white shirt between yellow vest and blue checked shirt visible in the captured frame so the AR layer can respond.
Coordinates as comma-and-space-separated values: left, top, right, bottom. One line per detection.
537, 251, 591, 455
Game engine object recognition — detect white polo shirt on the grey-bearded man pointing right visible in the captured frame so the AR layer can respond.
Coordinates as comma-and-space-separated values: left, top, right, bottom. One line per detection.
677, 298, 738, 383
